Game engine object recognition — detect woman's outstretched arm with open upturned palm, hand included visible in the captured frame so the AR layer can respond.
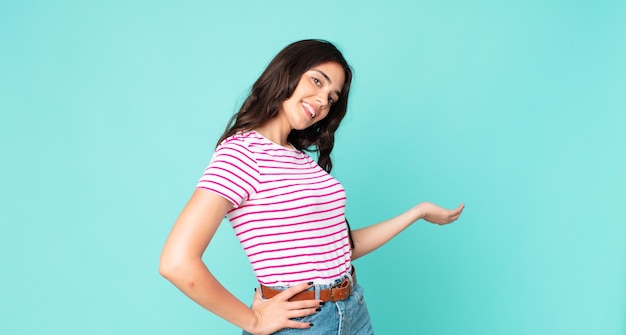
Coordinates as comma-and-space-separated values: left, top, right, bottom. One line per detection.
352, 202, 465, 260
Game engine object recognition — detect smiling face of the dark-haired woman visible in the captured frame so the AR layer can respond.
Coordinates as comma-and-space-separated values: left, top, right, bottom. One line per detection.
278, 62, 345, 130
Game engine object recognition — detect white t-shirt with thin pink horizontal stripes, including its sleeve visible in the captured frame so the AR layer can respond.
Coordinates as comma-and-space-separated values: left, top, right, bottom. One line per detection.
197, 131, 351, 286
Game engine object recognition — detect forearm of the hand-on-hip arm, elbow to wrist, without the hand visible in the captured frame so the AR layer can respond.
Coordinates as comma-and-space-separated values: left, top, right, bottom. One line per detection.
161, 259, 256, 332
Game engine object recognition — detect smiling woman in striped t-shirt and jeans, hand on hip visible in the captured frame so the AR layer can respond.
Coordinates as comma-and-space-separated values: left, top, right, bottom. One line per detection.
160, 40, 463, 334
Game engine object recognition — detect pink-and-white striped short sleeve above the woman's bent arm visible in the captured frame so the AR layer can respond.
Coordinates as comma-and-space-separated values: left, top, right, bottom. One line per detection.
196, 139, 259, 207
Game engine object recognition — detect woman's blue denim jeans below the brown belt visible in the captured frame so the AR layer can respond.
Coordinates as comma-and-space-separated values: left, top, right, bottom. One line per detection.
243, 280, 374, 335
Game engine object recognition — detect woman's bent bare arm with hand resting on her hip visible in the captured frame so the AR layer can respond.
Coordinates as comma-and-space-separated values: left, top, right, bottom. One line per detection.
159, 189, 320, 334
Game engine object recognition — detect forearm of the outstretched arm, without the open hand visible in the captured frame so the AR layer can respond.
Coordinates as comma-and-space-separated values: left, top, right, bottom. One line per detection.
352, 206, 424, 260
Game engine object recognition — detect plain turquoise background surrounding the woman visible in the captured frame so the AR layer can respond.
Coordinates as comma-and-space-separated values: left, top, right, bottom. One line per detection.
0, 0, 626, 334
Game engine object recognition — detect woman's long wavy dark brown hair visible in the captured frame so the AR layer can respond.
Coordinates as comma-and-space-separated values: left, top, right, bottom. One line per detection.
217, 40, 352, 172
